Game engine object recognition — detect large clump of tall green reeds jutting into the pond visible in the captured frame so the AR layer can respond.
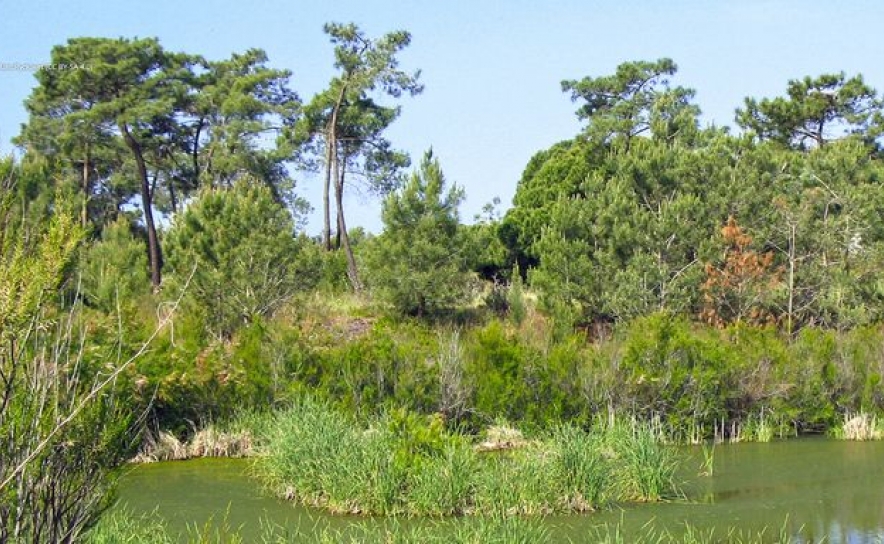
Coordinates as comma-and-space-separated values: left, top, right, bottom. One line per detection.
257, 399, 677, 517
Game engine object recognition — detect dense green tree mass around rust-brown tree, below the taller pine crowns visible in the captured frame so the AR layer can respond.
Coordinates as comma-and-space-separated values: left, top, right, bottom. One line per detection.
516, 91, 884, 333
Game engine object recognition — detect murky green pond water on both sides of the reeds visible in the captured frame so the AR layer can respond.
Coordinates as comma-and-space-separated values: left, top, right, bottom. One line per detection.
114, 440, 884, 544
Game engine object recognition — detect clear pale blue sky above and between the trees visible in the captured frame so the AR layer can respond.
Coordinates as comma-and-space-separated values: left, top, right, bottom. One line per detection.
0, 0, 884, 232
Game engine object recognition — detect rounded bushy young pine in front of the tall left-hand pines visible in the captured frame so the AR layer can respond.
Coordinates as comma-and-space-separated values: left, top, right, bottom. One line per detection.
165, 180, 316, 338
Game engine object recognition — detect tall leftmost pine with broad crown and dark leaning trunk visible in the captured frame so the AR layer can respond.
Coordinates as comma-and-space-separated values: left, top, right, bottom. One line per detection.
21, 38, 195, 288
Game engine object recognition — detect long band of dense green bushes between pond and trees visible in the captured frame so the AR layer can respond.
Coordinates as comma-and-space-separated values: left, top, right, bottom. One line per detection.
126, 288, 884, 441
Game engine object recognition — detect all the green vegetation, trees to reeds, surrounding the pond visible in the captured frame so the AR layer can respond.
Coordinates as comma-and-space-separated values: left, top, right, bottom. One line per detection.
0, 18, 884, 542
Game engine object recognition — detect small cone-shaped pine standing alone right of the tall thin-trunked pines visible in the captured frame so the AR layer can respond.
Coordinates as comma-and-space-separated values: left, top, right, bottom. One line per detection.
368, 151, 470, 315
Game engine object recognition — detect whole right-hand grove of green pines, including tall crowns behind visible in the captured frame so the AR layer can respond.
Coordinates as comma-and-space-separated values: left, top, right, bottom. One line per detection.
499, 59, 884, 334
